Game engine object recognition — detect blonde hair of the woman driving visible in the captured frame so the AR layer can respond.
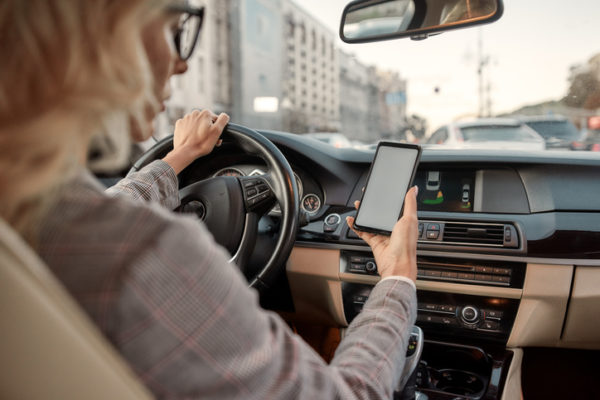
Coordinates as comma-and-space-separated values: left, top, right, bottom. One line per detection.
0, 0, 166, 238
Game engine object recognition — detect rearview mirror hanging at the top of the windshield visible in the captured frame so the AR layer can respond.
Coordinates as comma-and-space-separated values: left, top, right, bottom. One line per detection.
340, 0, 504, 43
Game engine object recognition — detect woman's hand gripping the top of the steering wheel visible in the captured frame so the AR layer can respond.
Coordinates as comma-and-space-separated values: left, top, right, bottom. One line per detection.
163, 110, 229, 174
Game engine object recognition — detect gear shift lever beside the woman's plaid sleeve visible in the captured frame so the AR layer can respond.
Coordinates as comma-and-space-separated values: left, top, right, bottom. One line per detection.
394, 326, 427, 400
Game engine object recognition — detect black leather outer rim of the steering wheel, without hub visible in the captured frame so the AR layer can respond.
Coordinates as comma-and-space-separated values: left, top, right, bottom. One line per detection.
129, 124, 299, 291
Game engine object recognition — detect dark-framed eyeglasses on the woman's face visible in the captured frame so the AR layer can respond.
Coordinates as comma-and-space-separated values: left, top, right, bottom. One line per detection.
168, 4, 204, 61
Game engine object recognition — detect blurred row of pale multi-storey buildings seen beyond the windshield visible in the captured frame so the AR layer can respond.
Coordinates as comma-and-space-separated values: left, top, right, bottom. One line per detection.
156, 0, 406, 143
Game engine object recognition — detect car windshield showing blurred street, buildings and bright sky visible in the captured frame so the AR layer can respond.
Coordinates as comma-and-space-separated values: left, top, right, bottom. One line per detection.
158, 0, 600, 151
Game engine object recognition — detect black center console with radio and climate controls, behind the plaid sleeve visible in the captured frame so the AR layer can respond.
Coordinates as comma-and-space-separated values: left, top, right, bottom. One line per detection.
340, 251, 525, 399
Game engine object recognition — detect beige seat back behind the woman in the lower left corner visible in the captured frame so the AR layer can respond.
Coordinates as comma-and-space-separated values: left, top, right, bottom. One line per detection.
0, 220, 152, 400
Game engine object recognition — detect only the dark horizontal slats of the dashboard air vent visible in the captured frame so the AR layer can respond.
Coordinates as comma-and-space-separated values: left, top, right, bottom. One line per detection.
444, 223, 504, 246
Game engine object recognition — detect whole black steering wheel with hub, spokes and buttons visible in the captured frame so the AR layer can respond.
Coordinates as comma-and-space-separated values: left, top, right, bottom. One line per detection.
130, 124, 299, 291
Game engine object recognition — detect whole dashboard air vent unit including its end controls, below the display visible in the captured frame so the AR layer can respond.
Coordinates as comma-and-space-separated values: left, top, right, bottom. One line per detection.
419, 221, 519, 249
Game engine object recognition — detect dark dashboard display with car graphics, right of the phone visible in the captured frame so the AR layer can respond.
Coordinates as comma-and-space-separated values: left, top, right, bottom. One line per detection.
414, 169, 475, 212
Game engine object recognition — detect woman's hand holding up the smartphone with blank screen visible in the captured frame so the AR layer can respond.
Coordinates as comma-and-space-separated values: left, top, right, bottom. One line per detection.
346, 186, 419, 282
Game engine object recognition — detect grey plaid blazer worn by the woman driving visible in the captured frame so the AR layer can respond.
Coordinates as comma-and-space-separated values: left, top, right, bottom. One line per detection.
38, 161, 416, 400
